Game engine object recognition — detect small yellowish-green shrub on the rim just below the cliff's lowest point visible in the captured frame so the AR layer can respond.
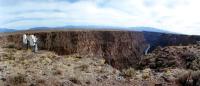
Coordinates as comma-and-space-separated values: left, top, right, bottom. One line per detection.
120, 68, 136, 77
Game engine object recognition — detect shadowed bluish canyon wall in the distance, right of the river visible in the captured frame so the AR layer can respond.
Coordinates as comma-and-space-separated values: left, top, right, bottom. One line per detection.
144, 32, 200, 51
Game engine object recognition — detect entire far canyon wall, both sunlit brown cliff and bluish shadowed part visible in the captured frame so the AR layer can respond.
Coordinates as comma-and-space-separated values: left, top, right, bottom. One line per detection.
7, 30, 200, 69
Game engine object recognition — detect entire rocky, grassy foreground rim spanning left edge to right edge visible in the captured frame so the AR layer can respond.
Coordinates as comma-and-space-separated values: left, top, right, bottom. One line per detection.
0, 38, 200, 86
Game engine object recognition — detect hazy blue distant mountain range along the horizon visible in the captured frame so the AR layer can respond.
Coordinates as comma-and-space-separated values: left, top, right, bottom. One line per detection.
0, 26, 174, 33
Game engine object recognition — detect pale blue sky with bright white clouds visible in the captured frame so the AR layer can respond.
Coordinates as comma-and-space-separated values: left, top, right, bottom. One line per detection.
0, 0, 200, 35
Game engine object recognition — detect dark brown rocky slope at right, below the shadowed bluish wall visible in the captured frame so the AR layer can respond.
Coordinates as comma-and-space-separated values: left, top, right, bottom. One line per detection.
140, 44, 200, 70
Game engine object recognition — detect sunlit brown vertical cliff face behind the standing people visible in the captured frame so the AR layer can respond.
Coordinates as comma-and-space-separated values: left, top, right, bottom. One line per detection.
5, 31, 146, 69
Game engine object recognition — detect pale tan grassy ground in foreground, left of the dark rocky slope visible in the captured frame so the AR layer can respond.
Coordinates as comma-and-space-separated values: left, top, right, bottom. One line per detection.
0, 42, 162, 86
